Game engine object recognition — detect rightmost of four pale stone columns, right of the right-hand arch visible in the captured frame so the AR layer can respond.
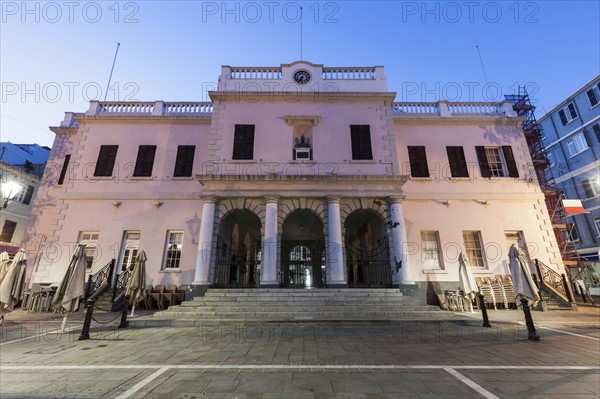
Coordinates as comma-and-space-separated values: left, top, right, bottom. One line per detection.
389, 197, 415, 285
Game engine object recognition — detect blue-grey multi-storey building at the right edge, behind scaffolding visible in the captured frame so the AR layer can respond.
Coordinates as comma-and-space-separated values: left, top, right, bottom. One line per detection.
539, 76, 600, 294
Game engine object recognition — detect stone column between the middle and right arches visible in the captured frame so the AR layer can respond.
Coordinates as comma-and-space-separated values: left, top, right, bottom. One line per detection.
327, 197, 348, 288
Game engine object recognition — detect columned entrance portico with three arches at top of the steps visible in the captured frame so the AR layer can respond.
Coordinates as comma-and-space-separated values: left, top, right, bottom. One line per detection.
193, 175, 411, 292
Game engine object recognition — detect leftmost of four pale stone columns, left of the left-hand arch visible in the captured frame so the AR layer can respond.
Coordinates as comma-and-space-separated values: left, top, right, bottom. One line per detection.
190, 196, 217, 296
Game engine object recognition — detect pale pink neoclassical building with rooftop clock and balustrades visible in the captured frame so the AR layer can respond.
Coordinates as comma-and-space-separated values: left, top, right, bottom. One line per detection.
23, 61, 564, 304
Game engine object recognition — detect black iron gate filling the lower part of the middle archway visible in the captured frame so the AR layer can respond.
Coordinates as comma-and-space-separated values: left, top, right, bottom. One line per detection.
280, 238, 326, 288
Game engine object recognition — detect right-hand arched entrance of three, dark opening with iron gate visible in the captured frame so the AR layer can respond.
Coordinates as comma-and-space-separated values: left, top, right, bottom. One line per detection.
344, 210, 392, 288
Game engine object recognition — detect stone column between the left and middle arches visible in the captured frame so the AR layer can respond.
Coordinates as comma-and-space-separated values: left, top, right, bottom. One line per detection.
260, 196, 279, 287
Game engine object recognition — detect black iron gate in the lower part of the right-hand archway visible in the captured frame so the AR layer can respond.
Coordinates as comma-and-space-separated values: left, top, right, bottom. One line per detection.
346, 237, 392, 288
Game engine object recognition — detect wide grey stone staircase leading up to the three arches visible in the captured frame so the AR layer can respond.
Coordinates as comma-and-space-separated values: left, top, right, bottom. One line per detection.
131, 288, 453, 326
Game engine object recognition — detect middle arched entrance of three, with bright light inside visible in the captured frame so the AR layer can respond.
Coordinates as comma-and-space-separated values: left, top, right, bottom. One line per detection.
280, 209, 326, 288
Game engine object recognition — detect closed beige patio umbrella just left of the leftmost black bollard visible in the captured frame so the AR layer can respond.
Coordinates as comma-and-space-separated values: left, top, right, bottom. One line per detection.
52, 244, 85, 332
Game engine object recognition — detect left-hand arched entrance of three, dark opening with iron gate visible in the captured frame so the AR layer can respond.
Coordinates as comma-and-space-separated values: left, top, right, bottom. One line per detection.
214, 209, 261, 288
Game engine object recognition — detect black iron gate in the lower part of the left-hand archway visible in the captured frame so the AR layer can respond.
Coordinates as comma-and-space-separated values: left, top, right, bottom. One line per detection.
214, 237, 261, 288
